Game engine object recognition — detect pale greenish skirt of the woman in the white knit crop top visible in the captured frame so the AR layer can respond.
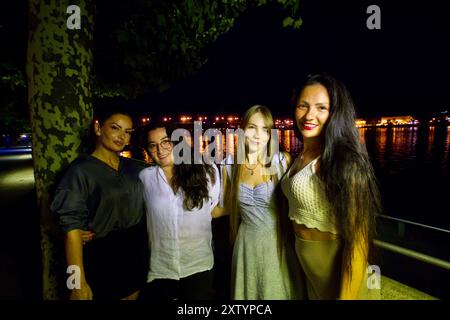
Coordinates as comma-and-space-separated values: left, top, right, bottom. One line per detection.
295, 237, 380, 300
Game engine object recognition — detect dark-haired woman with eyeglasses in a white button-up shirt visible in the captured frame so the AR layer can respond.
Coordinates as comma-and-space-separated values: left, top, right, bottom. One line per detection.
140, 123, 220, 300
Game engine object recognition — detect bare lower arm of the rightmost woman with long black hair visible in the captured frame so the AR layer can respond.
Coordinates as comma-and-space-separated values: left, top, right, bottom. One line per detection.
339, 236, 368, 300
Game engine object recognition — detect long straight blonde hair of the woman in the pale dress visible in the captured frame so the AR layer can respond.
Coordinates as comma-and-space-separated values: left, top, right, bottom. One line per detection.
225, 105, 278, 243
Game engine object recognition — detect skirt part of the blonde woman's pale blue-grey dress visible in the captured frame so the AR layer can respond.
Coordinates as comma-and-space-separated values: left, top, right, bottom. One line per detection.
231, 223, 306, 300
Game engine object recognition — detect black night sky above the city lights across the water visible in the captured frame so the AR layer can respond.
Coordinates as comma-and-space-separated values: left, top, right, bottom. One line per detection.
139, 0, 450, 117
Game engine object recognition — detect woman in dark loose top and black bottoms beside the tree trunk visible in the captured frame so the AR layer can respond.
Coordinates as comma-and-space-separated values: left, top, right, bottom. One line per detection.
52, 109, 149, 300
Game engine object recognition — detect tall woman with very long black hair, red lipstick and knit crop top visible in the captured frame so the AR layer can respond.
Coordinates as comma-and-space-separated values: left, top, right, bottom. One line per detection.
281, 74, 381, 299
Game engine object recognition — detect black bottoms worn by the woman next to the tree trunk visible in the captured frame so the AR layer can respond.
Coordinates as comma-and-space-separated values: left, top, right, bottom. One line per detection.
83, 219, 149, 300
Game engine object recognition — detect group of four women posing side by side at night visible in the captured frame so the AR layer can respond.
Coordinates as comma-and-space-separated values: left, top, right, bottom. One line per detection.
52, 74, 381, 300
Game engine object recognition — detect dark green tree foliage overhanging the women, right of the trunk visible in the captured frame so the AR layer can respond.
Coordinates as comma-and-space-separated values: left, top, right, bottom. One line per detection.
93, 0, 301, 97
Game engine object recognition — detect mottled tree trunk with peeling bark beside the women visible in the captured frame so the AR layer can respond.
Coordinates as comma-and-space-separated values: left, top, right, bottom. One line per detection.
27, 0, 94, 299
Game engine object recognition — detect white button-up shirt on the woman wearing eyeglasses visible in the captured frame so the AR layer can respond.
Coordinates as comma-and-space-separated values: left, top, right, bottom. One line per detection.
139, 164, 220, 282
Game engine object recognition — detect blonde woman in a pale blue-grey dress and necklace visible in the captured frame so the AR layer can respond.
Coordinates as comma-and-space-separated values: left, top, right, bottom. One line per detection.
215, 105, 303, 300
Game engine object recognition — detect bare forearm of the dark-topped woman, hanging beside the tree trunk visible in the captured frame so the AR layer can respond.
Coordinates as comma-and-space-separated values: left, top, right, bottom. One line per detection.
65, 229, 92, 300
